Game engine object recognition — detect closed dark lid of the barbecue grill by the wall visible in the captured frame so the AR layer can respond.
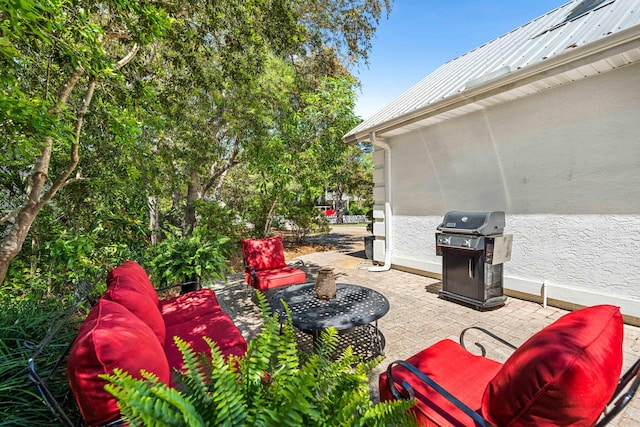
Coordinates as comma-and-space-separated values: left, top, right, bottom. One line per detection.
438, 211, 505, 236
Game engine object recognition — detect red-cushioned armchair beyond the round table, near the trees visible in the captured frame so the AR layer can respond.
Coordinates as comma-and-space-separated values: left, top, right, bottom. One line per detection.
242, 237, 307, 291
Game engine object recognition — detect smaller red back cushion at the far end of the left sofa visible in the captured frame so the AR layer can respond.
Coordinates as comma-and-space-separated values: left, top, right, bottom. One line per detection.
103, 261, 166, 344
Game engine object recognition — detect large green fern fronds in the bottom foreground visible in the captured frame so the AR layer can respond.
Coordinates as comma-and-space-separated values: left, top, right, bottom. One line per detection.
105, 294, 415, 427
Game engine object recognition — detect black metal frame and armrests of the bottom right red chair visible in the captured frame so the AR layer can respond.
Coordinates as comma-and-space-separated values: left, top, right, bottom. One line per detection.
387, 326, 640, 427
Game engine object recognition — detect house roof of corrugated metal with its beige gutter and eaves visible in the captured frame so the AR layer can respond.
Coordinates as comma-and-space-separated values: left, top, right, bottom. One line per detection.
343, 0, 640, 142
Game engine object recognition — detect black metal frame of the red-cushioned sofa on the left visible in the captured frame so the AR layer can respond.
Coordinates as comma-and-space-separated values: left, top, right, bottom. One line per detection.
23, 281, 198, 427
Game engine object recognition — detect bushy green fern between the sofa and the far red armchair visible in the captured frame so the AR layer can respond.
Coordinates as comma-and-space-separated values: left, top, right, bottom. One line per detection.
150, 226, 229, 284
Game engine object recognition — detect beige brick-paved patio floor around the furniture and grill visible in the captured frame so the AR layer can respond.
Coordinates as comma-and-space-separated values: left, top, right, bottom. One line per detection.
214, 226, 640, 426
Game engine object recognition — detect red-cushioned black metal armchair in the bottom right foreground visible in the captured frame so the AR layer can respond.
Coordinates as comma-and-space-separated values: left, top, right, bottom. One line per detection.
379, 305, 640, 426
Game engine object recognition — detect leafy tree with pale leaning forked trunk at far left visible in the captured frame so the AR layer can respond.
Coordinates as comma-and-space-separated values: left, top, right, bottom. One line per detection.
0, 0, 170, 283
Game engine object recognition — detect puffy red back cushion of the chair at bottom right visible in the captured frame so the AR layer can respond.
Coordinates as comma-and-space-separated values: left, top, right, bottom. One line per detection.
482, 305, 623, 426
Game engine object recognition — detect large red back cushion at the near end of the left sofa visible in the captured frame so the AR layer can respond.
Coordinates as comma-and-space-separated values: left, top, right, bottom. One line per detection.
67, 299, 170, 426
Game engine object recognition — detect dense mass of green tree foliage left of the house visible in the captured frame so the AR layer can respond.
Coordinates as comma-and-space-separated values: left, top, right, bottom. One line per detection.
0, 0, 382, 292
